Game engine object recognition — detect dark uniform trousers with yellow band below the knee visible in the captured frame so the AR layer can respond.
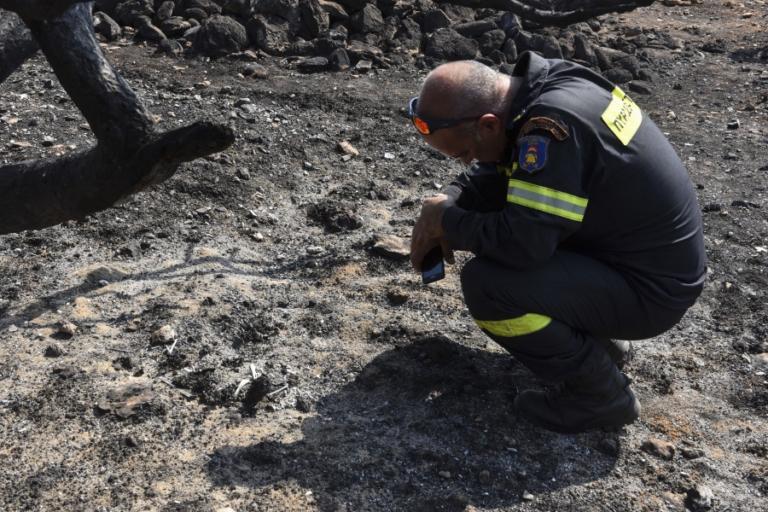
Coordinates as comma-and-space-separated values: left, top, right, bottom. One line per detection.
461, 251, 685, 382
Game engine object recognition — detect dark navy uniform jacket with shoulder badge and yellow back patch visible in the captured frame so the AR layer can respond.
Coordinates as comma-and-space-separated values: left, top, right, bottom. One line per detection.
443, 53, 706, 308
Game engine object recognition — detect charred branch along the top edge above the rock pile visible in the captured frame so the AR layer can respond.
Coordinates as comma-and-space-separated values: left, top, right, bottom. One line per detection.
437, 0, 655, 27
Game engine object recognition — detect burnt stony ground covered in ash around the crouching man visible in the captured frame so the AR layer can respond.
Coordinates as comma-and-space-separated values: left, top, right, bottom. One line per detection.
0, 1, 768, 512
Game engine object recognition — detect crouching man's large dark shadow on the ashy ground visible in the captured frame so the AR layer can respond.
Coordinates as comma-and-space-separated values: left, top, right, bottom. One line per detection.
207, 335, 618, 511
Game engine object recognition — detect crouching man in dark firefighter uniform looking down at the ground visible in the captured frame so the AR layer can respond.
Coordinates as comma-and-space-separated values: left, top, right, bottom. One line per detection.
409, 53, 706, 433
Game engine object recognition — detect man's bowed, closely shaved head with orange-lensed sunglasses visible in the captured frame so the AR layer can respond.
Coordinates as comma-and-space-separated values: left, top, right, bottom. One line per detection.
412, 61, 513, 164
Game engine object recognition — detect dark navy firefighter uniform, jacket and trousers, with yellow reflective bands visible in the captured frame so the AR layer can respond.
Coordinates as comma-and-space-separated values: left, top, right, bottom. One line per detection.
443, 53, 706, 380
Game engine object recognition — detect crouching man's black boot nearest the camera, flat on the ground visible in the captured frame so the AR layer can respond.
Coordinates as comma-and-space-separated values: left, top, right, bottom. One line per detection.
515, 341, 640, 434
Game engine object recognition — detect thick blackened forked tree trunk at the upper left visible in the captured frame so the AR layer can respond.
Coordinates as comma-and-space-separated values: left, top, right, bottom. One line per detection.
0, 0, 234, 234
